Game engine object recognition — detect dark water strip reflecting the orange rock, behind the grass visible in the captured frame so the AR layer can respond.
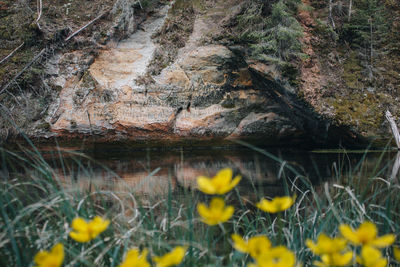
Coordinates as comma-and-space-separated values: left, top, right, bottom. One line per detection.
35, 148, 400, 198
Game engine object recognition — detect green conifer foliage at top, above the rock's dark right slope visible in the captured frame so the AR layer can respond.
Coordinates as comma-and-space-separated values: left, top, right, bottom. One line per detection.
237, 0, 302, 65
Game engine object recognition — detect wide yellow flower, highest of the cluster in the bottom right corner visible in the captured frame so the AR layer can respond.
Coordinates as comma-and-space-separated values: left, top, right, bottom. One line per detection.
339, 222, 395, 248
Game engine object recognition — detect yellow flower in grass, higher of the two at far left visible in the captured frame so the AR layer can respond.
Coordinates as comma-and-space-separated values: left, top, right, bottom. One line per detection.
69, 216, 110, 242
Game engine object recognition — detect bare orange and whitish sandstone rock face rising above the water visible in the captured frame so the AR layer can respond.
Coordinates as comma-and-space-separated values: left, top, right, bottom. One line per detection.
42, 0, 340, 147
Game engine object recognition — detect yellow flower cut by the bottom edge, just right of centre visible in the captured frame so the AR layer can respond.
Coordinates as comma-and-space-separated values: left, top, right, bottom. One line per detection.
247, 246, 296, 267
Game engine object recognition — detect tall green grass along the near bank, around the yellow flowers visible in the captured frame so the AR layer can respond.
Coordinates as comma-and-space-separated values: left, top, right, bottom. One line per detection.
0, 144, 400, 266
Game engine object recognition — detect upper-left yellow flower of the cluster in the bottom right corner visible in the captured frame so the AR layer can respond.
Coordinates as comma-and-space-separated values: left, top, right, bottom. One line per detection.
306, 233, 347, 255
